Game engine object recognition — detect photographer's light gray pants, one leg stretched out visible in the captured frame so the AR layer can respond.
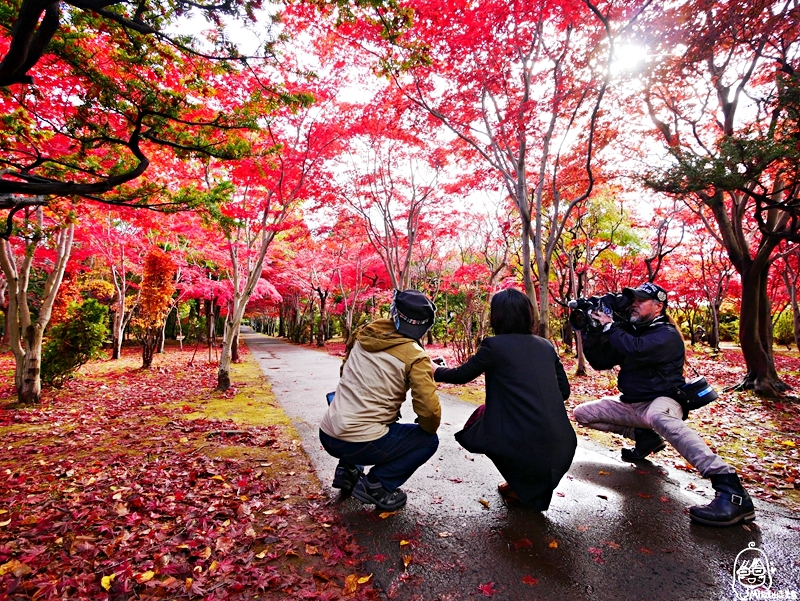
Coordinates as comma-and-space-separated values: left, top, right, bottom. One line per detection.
572, 396, 736, 477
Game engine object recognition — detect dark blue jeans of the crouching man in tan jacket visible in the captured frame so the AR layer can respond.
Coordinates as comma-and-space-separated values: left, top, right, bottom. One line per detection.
319, 422, 439, 492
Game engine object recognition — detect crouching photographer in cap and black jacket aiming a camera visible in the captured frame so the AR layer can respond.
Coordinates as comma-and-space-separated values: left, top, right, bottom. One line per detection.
570, 282, 755, 526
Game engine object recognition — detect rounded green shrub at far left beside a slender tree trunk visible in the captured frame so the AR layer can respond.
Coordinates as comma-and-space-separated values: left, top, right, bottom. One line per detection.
42, 299, 108, 387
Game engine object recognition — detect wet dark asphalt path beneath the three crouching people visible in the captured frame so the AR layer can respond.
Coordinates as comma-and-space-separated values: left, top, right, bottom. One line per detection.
242, 328, 800, 601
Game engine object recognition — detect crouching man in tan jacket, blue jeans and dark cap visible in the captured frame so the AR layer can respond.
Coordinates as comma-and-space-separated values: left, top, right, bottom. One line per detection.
319, 290, 441, 511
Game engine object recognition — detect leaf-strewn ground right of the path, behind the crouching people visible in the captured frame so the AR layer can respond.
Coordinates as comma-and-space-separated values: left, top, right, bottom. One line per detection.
312, 342, 800, 511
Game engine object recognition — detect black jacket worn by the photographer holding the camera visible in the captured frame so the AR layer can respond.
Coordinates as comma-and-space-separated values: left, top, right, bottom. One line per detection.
582, 316, 686, 403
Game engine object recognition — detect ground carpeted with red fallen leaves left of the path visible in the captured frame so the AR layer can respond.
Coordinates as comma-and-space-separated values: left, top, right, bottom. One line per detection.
0, 348, 376, 601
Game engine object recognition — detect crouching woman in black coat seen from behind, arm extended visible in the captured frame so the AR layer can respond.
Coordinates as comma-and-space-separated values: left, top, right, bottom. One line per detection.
434, 289, 578, 511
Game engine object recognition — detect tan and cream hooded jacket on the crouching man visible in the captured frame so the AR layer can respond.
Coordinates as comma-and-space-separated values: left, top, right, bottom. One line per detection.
319, 319, 442, 442
